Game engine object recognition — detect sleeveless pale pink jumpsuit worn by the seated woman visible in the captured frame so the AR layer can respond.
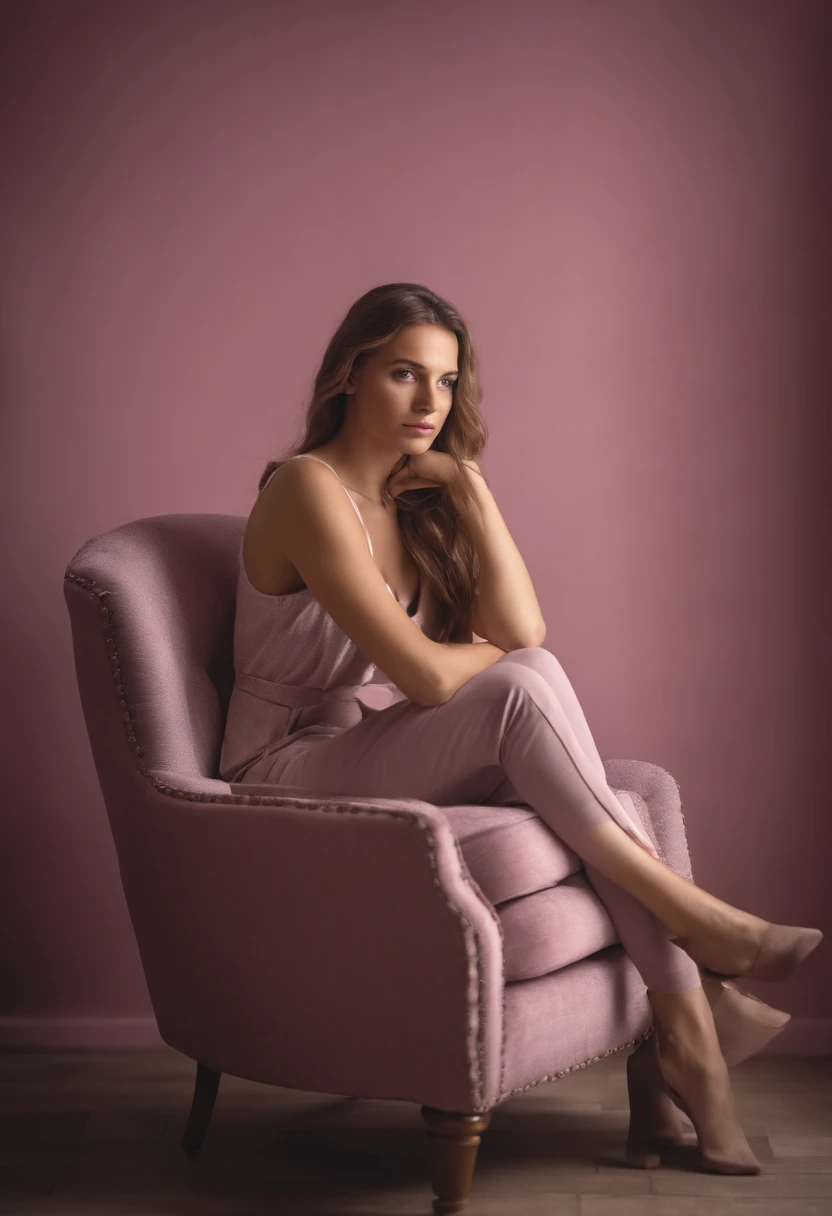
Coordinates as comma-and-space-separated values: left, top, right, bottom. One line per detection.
219, 452, 702, 992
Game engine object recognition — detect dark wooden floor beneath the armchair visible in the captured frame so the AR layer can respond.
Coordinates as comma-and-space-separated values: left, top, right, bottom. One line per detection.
0, 1049, 832, 1216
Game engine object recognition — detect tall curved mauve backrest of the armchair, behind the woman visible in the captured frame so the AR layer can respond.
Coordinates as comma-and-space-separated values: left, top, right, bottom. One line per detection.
63, 514, 246, 796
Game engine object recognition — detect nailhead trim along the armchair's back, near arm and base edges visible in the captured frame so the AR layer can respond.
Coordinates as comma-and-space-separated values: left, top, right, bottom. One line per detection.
63, 570, 661, 1114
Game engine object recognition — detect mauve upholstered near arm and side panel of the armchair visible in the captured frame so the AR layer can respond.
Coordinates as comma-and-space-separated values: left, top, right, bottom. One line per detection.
111, 777, 504, 1110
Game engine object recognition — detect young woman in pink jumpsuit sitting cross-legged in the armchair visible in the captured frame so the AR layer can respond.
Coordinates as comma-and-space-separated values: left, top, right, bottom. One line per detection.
220, 283, 822, 1173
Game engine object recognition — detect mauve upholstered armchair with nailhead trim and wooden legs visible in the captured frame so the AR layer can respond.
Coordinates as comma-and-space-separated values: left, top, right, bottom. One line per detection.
64, 514, 692, 1214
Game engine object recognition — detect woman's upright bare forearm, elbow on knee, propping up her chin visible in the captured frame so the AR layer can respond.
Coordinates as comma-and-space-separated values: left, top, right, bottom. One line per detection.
463, 460, 546, 651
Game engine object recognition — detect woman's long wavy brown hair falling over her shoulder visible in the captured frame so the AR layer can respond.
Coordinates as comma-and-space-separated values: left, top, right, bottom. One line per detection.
258, 283, 488, 642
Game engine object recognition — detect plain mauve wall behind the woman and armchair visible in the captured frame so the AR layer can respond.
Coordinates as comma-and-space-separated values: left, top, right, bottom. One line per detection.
0, 0, 832, 1051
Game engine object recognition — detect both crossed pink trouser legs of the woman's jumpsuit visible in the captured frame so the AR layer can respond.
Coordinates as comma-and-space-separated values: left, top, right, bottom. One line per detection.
270, 646, 702, 992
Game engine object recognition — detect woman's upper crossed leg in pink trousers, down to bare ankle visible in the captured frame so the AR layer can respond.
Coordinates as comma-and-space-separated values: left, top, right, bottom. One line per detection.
271, 647, 766, 983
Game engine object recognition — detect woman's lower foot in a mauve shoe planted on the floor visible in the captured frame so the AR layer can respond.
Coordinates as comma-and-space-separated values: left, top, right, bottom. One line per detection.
656, 1025, 761, 1173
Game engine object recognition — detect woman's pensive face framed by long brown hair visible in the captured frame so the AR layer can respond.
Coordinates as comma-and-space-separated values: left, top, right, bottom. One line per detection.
347, 325, 459, 454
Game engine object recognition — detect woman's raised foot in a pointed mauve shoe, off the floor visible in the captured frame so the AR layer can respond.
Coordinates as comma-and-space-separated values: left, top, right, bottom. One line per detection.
671, 909, 823, 980
